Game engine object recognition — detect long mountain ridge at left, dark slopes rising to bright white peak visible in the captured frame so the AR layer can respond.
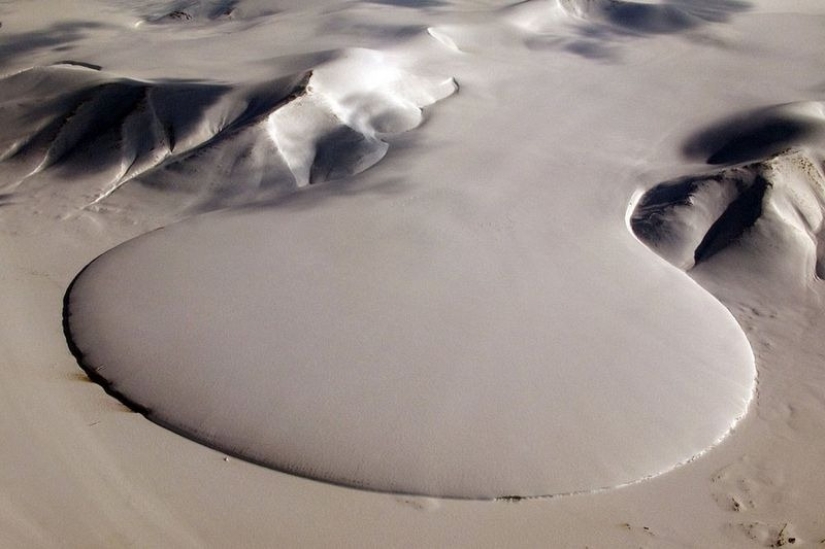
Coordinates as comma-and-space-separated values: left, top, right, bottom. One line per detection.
0, 49, 456, 209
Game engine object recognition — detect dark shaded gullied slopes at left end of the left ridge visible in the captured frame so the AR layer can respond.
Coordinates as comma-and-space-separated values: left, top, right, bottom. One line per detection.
0, 63, 231, 185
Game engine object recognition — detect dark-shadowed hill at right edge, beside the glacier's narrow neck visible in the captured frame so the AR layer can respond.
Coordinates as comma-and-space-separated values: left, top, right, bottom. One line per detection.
630, 102, 825, 283
